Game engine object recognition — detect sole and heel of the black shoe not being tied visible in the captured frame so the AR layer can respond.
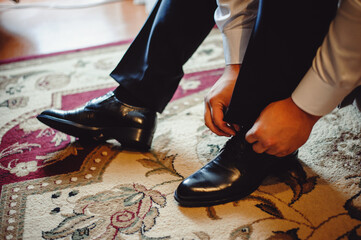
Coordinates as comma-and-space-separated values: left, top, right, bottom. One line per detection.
37, 114, 154, 151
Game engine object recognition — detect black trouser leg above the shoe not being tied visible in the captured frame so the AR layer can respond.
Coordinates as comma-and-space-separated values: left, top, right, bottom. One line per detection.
111, 0, 217, 112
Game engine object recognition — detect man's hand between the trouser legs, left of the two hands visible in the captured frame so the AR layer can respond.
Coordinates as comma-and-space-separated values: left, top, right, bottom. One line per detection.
204, 64, 240, 137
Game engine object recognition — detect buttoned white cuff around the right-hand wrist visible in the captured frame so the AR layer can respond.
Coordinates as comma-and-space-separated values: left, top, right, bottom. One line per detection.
292, 68, 352, 116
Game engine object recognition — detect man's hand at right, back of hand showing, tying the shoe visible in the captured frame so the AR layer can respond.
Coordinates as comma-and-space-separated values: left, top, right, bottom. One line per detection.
246, 98, 321, 157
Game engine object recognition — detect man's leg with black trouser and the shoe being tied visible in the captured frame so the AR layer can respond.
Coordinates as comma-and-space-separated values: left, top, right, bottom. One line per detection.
175, 0, 337, 207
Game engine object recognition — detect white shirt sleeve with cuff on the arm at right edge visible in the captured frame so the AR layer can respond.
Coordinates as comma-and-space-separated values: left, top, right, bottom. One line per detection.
292, 0, 361, 116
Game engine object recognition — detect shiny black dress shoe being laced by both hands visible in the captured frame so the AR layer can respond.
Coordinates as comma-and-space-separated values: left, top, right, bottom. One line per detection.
174, 135, 297, 207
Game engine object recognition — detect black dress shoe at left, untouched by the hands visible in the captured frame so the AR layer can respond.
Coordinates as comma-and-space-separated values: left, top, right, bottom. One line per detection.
37, 92, 157, 150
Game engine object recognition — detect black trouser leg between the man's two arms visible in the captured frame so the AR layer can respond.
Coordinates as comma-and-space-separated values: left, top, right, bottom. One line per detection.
225, 0, 338, 130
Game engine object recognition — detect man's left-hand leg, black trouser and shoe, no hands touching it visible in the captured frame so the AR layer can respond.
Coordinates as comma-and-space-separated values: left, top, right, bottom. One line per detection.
38, 0, 217, 150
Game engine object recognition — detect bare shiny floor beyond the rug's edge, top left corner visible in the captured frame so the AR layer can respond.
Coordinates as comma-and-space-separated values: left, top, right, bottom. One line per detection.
0, 0, 147, 61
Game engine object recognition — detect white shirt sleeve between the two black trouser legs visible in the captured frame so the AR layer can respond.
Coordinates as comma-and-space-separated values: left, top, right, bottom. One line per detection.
214, 0, 258, 65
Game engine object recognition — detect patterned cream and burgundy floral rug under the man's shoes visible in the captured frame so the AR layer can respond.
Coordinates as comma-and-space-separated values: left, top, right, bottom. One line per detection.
0, 30, 361, 240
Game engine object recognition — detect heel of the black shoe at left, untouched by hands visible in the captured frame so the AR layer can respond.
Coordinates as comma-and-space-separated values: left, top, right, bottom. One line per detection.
112, 128, 154, 151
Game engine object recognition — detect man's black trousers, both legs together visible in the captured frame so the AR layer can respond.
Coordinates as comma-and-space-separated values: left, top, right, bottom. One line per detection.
111, 0, 338, 128
